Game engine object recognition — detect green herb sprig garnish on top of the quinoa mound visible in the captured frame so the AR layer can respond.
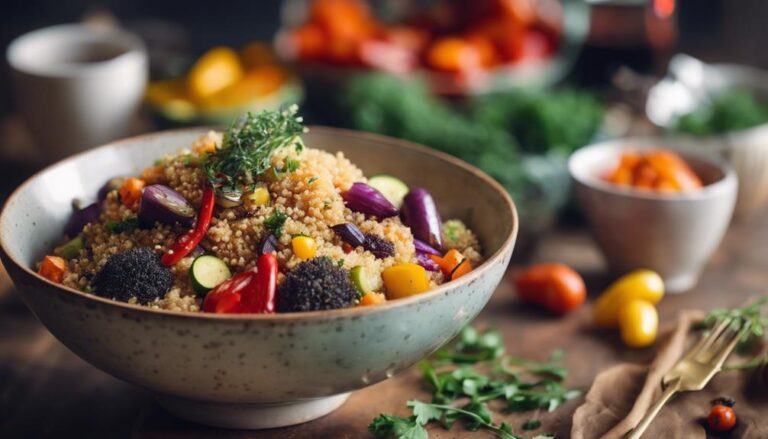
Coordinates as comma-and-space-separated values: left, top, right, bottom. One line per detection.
203, 105, 306, 192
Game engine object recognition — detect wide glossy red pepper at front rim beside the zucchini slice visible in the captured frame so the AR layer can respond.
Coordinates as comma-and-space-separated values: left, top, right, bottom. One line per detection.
203, 253, 277, 314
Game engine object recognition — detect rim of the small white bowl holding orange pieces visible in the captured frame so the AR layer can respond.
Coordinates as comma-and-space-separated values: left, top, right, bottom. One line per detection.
568, 136, 737, 203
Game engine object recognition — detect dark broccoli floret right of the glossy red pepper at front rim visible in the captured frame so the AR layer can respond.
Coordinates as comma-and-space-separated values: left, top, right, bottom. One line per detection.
277, 257, 357, 312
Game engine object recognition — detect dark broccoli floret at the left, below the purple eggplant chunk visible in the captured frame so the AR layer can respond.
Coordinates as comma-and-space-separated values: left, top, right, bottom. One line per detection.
91, 247, 173, 304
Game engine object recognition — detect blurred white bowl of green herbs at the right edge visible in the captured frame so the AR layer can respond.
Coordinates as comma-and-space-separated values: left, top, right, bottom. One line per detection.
646, 55, 768, 217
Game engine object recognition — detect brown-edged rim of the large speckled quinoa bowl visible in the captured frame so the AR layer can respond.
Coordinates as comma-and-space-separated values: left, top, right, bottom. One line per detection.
0, 126, 520, 321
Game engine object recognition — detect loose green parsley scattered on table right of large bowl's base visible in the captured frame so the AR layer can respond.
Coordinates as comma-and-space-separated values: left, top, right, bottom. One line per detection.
368, 326, 581, 439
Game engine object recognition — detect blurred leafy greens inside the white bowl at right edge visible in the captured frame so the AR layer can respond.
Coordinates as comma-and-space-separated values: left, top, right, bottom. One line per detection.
677, 88, 768, 136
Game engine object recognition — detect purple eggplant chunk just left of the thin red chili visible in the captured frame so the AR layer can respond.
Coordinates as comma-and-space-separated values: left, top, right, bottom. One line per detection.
139, 184, 195, 228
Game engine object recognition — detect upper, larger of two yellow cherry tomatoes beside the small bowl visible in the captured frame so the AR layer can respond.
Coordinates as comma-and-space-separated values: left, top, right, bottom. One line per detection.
594, 270, 664, 326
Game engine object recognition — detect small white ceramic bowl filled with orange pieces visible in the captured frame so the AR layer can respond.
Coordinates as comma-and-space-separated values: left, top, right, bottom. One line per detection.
568, 138, 738, 293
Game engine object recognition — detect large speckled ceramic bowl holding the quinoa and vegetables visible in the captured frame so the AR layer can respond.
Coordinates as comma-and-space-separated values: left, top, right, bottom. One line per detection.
0, 127, 518, 428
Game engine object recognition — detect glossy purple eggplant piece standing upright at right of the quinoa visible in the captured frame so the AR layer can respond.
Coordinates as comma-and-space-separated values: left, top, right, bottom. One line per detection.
400, 188, 443, 250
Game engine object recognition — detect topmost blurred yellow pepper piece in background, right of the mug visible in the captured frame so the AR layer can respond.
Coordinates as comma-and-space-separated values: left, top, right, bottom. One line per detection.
187, 47, 243, 104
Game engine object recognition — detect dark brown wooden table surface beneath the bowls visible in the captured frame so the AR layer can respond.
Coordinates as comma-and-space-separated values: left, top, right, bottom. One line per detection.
0, 207, 768, 439
